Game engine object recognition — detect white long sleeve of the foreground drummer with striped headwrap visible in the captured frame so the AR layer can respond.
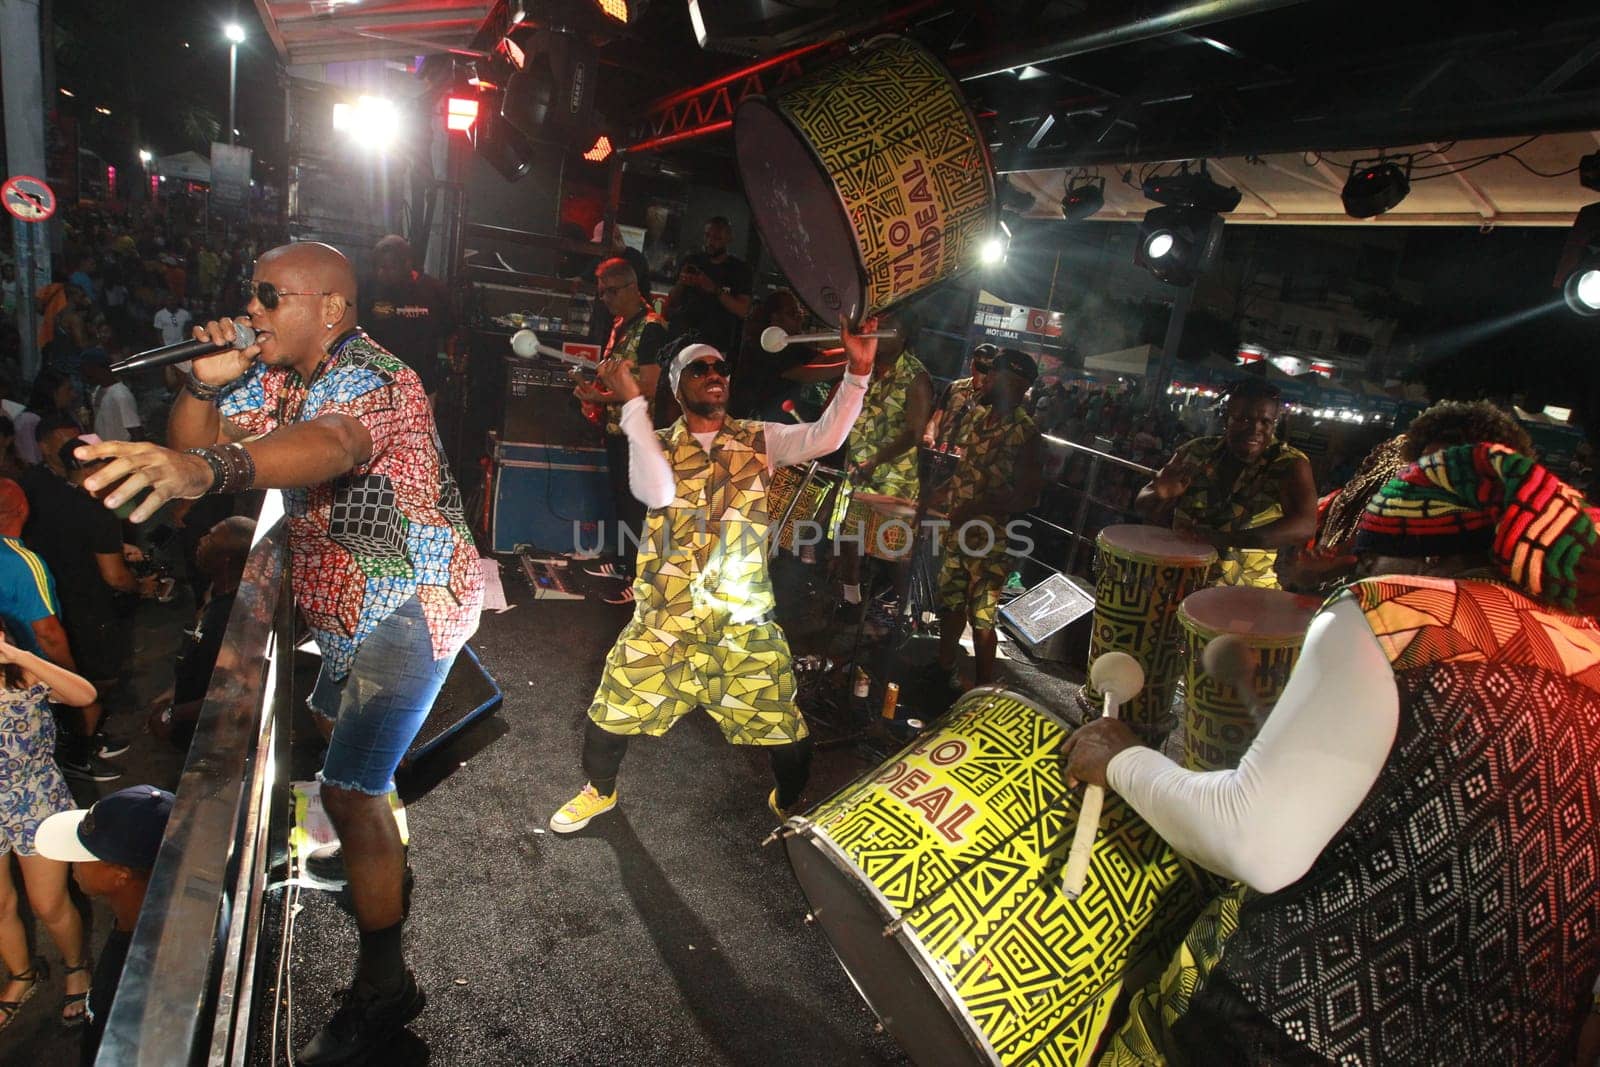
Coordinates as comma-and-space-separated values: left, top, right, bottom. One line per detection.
1106, 597, 1400, 893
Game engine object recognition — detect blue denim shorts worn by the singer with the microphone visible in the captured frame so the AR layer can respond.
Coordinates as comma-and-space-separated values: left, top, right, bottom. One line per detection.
309, 597, 456, 797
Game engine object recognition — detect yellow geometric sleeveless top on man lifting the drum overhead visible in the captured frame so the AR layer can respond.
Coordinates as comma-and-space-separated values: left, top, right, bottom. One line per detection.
634, 419, 774, 635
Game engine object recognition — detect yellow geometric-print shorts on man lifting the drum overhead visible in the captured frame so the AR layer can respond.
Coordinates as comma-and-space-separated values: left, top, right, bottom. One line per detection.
589, 619, 810, 745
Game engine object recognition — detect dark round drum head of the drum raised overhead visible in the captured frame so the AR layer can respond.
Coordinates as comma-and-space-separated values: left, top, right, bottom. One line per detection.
733, 98, 867, 326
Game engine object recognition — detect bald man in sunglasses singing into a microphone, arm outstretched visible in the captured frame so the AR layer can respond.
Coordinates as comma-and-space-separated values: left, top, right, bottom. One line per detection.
77, 243, 483, 1065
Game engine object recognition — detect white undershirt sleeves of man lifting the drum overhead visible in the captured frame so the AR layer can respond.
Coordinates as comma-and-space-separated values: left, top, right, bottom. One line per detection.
618, 374, 872, 507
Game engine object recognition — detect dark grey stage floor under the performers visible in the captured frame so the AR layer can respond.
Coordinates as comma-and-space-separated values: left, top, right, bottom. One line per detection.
259, 558, 1070, 1067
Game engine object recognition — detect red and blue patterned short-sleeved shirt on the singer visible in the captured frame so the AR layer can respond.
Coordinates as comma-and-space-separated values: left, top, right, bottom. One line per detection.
218, 334, 483, 677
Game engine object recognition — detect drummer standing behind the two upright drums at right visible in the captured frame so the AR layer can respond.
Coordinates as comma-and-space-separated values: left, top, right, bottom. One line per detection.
1133, 378, 1317, 589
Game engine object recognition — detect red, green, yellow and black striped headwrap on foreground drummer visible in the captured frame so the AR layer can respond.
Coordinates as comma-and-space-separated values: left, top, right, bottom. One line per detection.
1357, 445, 1600, 614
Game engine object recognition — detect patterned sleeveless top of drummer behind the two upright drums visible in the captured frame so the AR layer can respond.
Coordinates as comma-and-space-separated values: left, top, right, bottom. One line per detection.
1173, 437, 1309, 589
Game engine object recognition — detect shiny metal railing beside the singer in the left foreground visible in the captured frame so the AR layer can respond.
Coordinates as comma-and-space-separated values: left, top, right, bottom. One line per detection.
94, 491, 294, 1067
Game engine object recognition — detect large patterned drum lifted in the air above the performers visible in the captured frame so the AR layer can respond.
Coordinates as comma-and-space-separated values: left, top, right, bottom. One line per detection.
733, 37, 995, 325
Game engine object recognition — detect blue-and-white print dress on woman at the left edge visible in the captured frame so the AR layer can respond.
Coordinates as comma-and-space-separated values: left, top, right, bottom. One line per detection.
0, 683, 77, 862
